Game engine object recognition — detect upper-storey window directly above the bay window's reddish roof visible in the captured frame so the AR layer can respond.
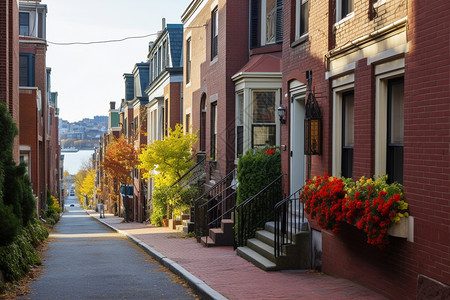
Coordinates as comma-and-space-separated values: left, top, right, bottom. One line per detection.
250, 0, 283, 48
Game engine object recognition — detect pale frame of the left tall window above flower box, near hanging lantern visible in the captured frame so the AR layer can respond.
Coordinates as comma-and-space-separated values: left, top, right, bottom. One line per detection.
331, 73, 355, 177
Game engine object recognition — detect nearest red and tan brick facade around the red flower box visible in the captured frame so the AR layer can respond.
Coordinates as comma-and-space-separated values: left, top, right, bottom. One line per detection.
282, 0, 450, 299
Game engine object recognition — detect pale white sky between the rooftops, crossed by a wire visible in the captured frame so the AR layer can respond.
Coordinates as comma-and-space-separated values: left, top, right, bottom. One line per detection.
46, 0, 191, 122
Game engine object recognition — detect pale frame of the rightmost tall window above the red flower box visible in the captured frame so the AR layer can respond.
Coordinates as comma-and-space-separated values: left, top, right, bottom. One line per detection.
375, 58, 405, 175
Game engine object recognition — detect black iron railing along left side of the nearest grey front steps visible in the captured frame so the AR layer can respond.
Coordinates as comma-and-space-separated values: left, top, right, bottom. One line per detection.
234, 174, 284, 248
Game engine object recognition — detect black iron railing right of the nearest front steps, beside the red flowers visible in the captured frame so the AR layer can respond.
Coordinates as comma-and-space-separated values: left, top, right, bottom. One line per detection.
274, 189, 307, 257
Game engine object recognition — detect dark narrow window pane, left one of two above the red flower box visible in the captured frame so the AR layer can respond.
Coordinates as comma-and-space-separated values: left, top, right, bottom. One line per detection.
341, 91, 354, 178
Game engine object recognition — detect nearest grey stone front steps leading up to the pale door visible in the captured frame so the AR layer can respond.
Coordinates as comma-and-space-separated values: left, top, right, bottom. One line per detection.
237, 222, 311, 271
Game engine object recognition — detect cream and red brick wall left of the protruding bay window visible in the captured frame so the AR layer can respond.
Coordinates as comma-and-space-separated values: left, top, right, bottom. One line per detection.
183, 0, 249, 181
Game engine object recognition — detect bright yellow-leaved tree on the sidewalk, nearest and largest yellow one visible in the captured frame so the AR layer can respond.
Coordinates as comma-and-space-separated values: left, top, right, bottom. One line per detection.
139, 124, 197, 225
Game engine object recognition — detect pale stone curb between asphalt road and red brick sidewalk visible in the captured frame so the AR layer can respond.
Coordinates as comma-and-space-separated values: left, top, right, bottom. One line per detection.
86, 211, 227, 300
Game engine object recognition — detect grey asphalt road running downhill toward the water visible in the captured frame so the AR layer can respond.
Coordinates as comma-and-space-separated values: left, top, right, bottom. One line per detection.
25, 197, 194, 299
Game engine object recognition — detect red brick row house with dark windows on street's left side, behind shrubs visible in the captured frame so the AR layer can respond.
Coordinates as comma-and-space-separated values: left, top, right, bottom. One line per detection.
18, 1, 61, 213
